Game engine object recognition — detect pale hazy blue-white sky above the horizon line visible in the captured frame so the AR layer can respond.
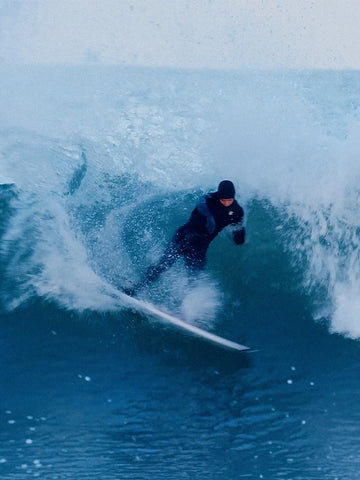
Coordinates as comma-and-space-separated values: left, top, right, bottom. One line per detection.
0, 0, 360, 70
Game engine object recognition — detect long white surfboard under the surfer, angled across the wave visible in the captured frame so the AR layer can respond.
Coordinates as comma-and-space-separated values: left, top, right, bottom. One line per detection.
118, 292, 250, 352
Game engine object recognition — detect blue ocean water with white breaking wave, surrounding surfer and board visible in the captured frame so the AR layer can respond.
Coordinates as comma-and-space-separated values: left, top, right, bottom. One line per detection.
0, 66, 360, 480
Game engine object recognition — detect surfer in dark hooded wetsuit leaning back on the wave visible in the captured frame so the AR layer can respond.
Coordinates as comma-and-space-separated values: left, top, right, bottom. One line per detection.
124, 180, 245, 295
